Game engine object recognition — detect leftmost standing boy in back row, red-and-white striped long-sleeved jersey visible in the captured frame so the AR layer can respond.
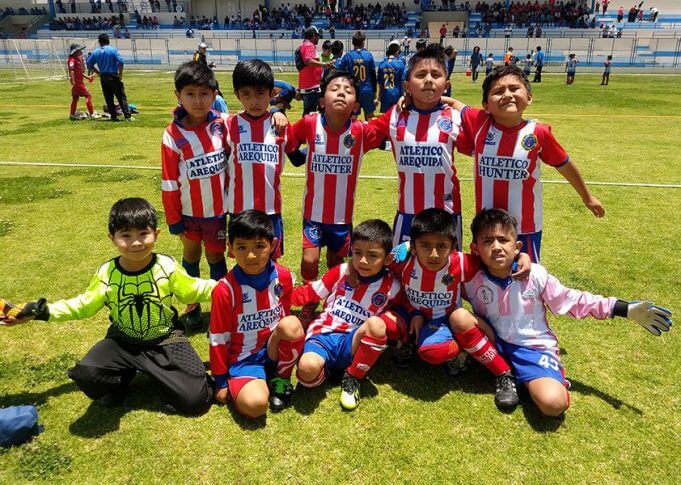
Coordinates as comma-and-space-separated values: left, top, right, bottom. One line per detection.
161, 61, 228, 328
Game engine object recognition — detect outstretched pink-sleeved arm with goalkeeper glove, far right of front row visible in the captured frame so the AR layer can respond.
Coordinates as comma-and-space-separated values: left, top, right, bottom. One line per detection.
541, 270, 672, 336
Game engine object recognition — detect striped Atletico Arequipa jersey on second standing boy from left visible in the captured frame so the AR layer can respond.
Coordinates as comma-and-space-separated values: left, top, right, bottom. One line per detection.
227, 113, 295, 214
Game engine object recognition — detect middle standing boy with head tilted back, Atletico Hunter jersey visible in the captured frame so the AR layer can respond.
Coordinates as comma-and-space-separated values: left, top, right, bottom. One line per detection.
290, 70, 384, 286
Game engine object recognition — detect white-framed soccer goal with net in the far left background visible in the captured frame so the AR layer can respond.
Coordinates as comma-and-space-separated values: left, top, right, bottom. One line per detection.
8, 39, 67, 80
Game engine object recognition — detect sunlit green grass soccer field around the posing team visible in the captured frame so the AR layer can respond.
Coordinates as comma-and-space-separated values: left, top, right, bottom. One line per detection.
0, 71, 681, 483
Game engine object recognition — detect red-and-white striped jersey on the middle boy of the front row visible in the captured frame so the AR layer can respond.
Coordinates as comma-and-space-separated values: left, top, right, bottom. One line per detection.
291, 263, 400, 337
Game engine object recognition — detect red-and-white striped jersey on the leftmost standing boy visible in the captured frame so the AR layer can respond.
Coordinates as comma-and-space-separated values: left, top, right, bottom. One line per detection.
161, 107, 228, 226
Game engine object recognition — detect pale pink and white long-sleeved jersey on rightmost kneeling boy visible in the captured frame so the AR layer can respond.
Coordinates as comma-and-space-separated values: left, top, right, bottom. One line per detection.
464, 264, 617, 355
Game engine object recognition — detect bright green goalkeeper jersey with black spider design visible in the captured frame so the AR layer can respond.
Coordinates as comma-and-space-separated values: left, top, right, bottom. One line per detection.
48, 254, 217, 343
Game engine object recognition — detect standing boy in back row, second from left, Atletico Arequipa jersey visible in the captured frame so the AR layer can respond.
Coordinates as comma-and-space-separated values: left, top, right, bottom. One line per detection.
227, 59, 296, 259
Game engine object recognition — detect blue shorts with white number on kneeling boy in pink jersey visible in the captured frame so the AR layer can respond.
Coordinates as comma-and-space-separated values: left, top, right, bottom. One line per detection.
496, 337, 570, 388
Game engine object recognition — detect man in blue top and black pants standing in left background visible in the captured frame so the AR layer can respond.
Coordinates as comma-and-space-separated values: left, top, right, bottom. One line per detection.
87, 34, 132, 121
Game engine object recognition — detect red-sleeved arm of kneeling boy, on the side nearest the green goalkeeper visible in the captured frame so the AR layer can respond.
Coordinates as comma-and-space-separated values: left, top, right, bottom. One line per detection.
208, 282, 233, 404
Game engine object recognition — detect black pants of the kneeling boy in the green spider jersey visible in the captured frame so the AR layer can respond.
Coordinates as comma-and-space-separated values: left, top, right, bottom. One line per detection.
68, 338, 213, 415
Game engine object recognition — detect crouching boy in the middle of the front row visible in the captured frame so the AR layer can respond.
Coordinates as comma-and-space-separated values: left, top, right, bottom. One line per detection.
292, 219, 400, 411
